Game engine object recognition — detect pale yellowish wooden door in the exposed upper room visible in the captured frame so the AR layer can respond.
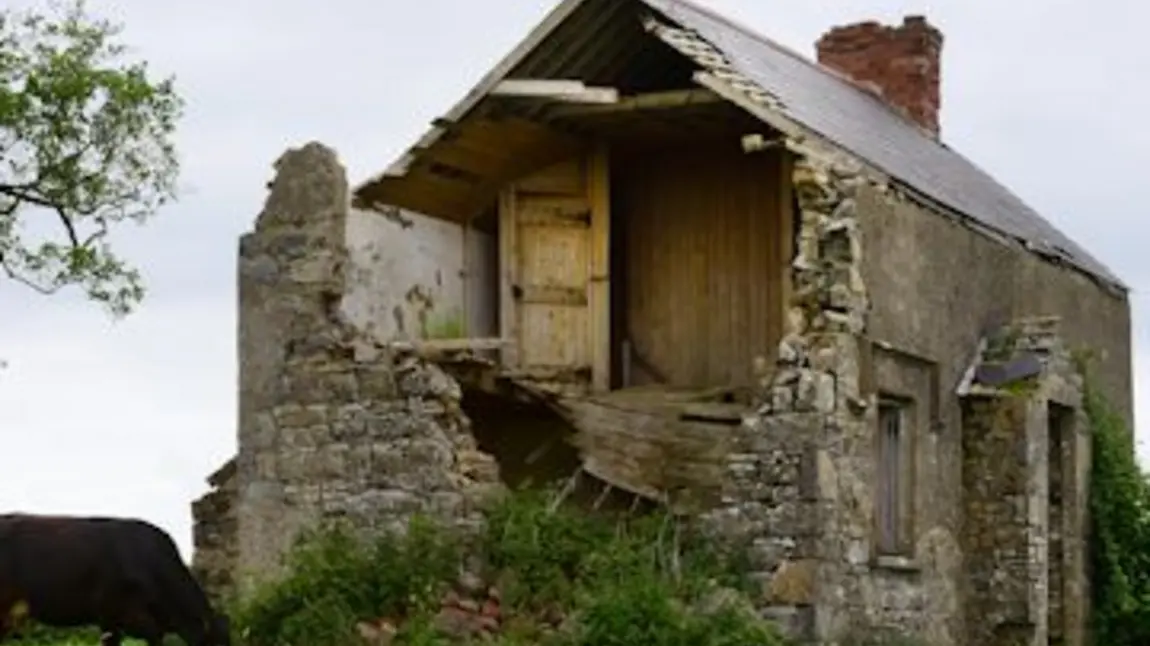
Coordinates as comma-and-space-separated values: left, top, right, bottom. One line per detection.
499, 153, 611, 390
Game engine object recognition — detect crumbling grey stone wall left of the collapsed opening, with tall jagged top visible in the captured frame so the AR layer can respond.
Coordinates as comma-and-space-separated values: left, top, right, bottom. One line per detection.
197, 143, 498, 587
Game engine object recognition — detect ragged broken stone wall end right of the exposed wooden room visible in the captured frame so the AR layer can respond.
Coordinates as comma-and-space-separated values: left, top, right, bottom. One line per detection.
690, 143, 869, 639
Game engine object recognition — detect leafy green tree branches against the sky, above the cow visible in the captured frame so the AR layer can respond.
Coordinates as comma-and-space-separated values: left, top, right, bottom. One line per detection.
0, 0, 183, 316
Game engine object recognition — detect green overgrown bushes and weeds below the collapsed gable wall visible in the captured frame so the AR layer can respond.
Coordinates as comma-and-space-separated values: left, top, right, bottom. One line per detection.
235, 492, 783, 646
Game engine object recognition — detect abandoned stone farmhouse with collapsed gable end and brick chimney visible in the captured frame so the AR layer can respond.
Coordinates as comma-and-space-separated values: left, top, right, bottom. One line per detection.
193, 0, 1133, 646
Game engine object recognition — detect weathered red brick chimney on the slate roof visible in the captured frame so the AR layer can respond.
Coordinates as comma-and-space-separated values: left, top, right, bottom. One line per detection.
815, 16, 943, 137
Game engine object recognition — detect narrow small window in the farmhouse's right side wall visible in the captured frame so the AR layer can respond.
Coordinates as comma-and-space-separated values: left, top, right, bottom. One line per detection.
875, 401, 910, 555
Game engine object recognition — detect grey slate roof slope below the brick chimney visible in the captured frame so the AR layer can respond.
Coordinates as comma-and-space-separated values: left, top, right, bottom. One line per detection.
642, 0, 1125, 289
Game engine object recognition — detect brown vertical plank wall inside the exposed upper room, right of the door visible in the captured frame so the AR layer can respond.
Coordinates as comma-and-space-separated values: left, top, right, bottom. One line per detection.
611, 139, 792, 387
